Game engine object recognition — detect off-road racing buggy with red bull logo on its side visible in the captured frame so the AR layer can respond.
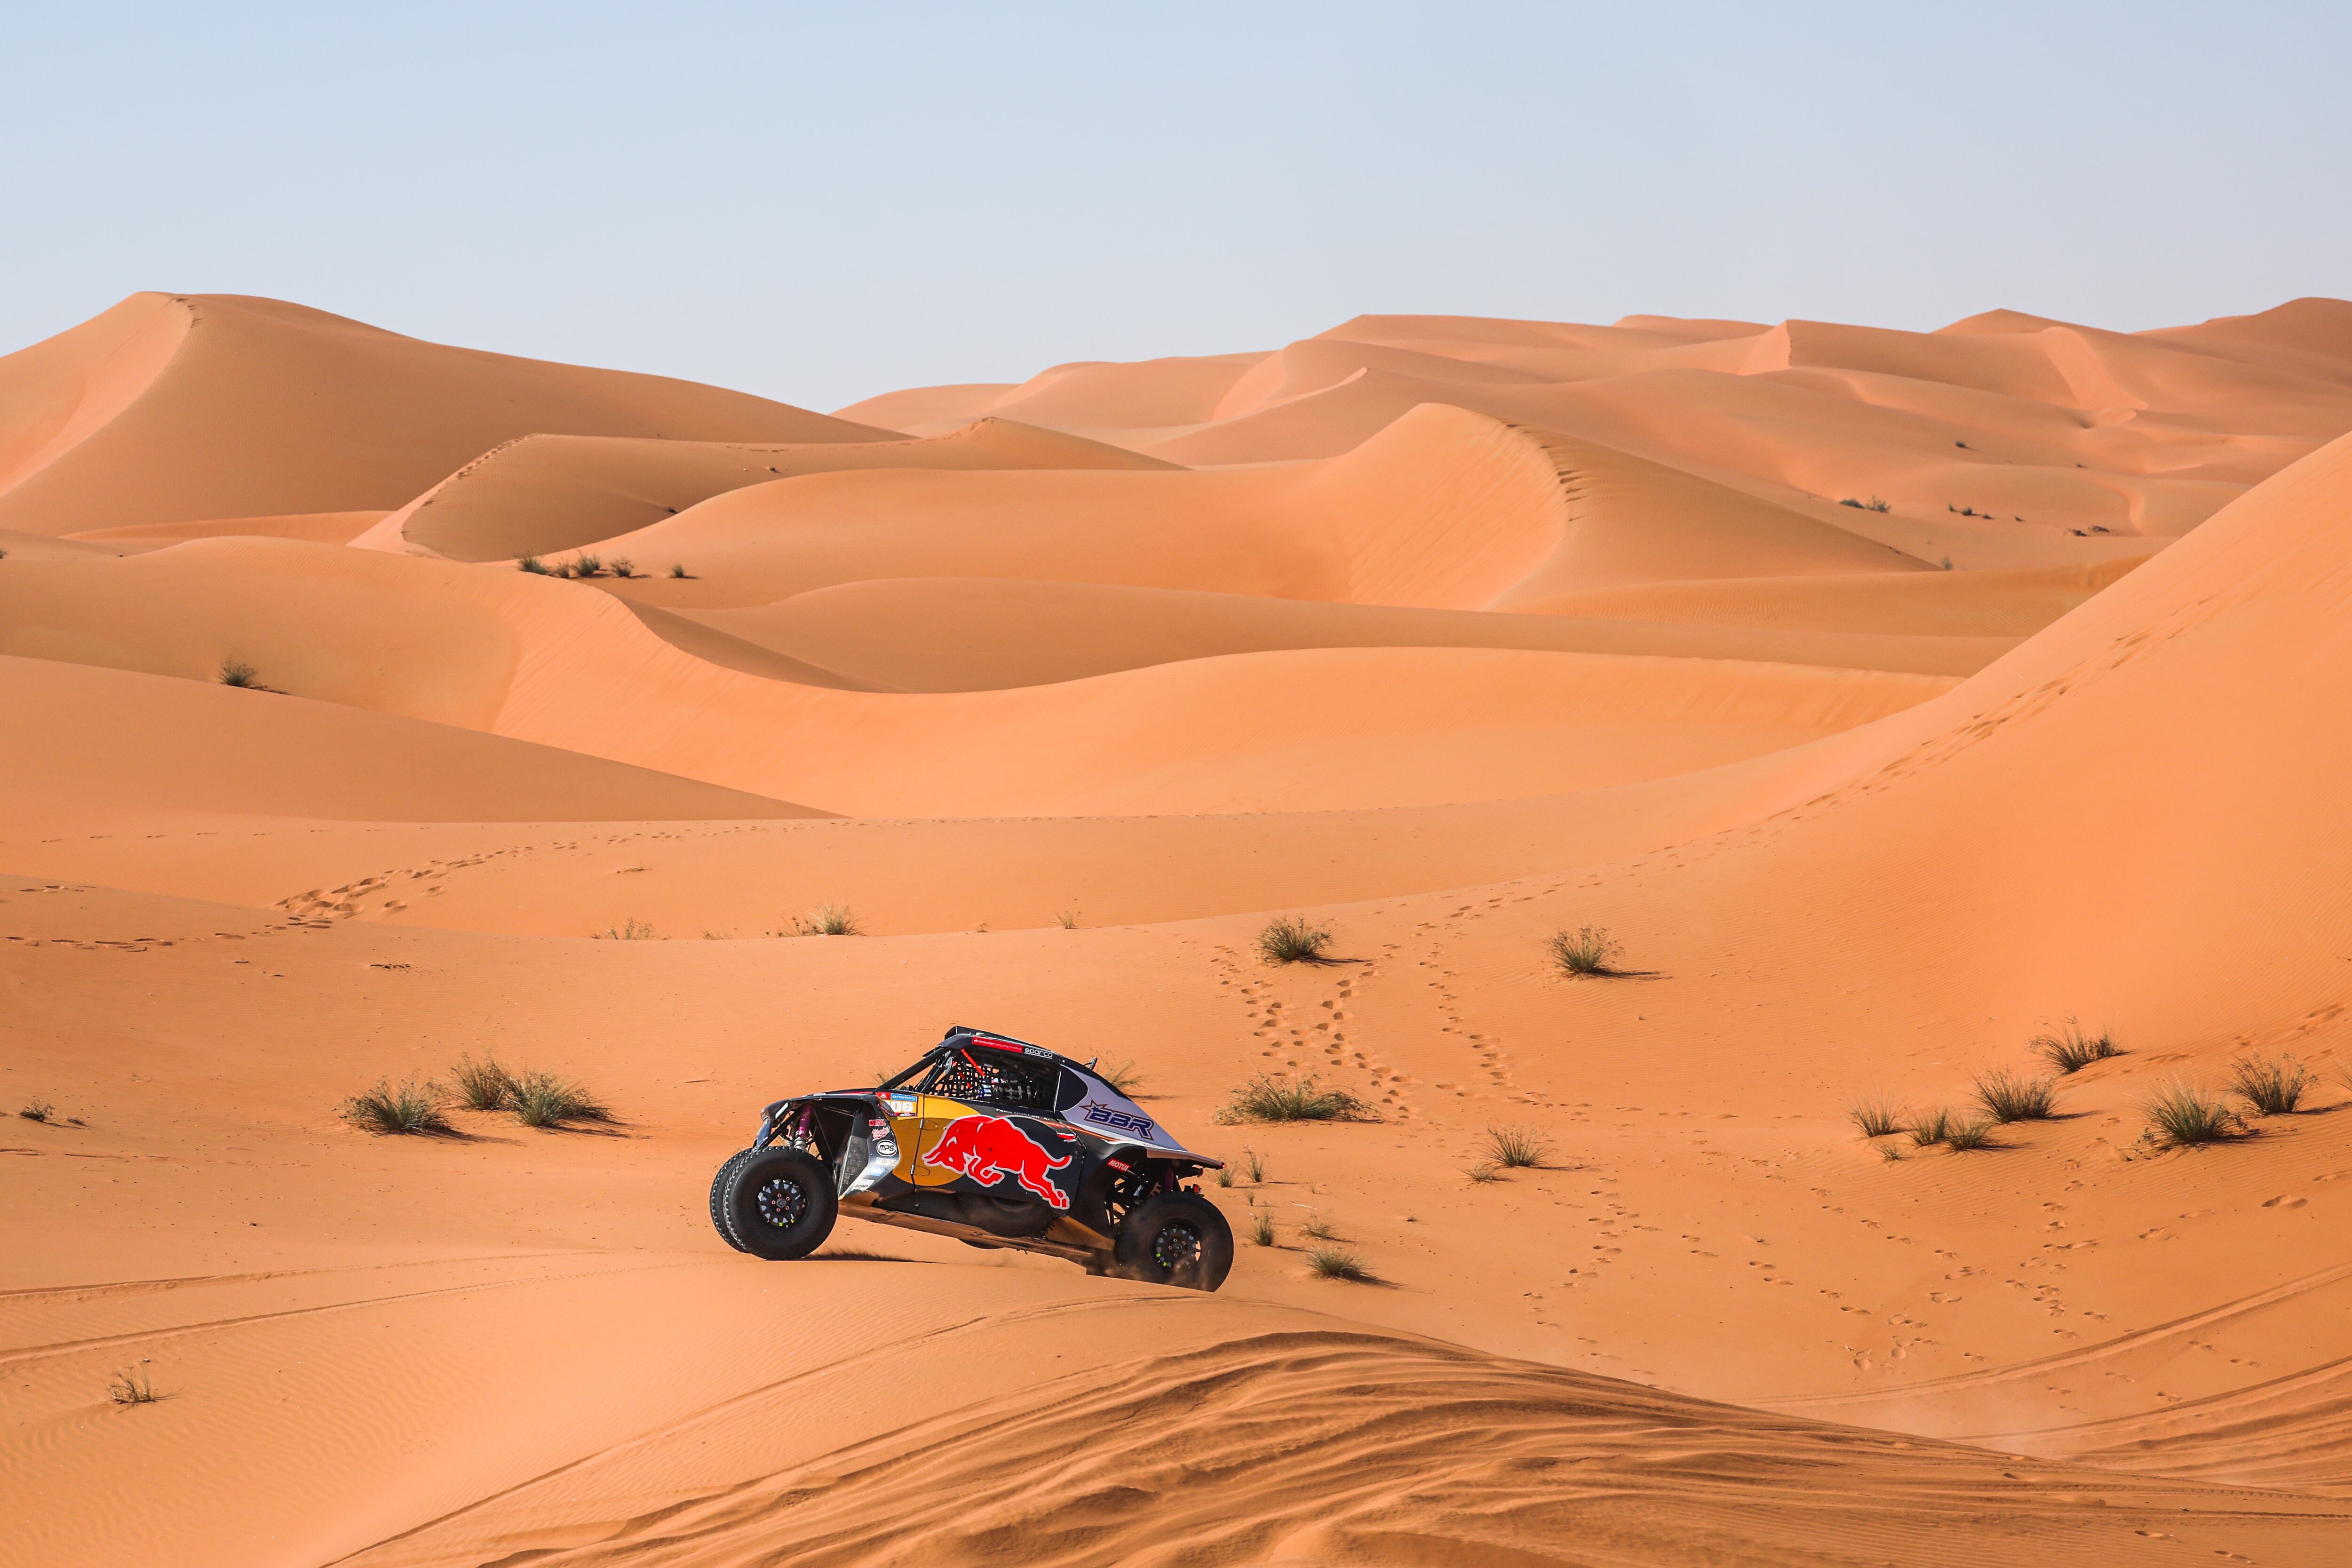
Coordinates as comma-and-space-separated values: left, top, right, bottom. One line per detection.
710, 1025, 1232, 1290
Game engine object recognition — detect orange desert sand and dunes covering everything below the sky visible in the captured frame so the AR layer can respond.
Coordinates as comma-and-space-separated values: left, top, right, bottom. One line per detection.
0, 294, 2352, 1568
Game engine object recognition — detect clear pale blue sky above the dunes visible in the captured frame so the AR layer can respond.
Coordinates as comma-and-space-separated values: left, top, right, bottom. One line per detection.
0, 0, 2352, 409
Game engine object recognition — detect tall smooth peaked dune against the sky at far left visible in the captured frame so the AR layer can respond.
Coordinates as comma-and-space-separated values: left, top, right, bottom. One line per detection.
0, 294, 884, 533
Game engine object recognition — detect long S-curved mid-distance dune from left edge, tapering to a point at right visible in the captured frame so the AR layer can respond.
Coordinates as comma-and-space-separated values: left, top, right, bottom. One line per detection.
0, 541, 1952, 816
